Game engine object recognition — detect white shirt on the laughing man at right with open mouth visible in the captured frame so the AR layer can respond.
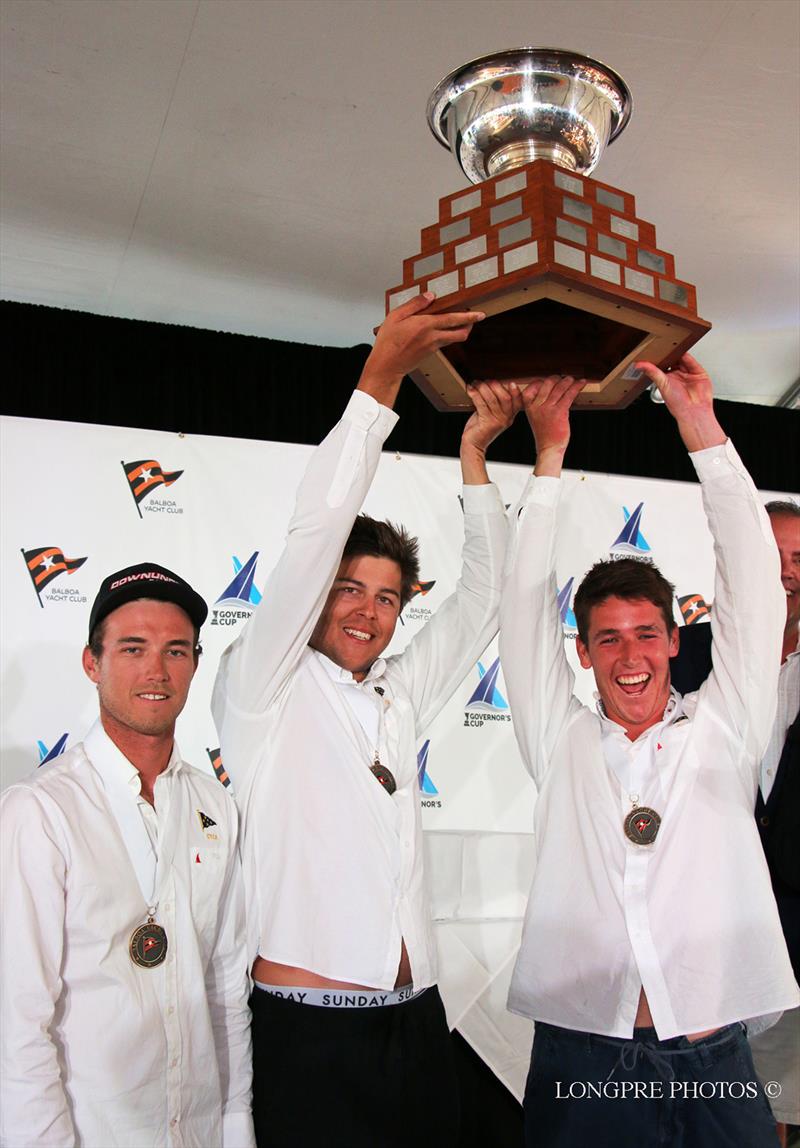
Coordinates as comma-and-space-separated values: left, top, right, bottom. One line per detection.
500, 442, 800, 1040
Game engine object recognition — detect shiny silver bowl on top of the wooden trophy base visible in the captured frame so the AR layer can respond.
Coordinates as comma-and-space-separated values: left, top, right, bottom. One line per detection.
427, 48, 634, 184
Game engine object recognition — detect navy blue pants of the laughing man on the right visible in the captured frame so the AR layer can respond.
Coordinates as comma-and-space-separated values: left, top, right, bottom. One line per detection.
522, 1023, 778, 1148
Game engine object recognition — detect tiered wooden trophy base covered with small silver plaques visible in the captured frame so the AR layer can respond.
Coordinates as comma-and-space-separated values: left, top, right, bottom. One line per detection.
386, 160, 710, 411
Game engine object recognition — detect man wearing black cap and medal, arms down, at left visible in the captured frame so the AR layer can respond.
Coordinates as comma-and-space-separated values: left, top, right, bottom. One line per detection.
0, 563, 253, 1148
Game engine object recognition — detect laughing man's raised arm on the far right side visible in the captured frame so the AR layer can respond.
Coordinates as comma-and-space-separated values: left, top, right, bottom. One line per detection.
637, 355, 786, 771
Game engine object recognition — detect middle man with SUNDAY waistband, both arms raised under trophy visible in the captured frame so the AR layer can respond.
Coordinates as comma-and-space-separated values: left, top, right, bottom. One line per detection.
213, 296, 519, 1148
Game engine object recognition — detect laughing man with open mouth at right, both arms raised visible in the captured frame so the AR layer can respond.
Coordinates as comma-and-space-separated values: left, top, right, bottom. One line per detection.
500, 356, 799, 1148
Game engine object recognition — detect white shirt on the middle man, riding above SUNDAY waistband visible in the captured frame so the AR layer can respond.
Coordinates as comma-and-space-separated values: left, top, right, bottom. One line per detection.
212, 391, 506, 988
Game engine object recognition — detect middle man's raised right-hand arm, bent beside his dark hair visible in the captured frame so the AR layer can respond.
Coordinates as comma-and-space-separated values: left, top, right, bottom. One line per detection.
390, 382, 521, 732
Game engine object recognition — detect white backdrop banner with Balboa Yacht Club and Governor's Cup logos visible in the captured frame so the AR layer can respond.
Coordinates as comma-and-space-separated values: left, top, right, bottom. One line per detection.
0, 416, 794, 1095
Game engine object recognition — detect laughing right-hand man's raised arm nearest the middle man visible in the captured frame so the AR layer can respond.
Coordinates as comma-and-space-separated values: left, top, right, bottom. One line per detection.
500, 375, 584, 784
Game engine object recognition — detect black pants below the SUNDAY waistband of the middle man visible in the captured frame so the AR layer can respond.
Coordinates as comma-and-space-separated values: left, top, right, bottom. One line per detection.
250, 987, 459, 1148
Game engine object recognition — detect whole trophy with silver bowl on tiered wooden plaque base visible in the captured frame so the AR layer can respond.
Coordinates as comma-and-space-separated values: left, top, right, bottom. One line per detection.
386, 48, 710, 411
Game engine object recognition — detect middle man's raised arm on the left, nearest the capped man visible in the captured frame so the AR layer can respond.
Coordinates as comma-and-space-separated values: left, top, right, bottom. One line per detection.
212, 294, 482, 725
